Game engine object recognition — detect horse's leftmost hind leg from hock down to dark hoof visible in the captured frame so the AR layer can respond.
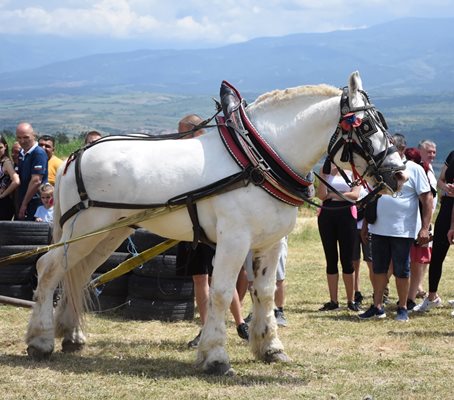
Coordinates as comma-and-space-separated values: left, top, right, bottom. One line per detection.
26, 249, 64, 360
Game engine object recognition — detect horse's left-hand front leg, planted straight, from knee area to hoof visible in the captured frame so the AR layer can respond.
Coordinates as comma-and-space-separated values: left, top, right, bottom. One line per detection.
197, 239, 249, 375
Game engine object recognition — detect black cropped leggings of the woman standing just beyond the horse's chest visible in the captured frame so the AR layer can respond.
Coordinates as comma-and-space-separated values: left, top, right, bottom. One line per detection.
318, 201, 356, 275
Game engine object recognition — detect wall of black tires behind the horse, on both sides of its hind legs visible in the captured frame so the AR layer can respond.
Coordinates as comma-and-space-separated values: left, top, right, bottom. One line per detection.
0, 221, 194, 321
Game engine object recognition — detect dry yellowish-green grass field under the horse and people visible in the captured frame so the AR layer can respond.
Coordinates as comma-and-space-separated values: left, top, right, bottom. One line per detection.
0, 211, 454, 400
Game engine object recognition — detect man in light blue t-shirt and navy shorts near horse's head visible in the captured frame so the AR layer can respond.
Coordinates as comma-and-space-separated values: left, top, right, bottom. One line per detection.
358, 134, 433, 322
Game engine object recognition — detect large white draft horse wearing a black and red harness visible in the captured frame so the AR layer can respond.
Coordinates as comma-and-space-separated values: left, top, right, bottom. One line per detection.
26, 72, 405, 374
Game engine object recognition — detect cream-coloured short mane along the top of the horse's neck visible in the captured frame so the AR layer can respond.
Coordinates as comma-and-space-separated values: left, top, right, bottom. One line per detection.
254, 84, 341, 106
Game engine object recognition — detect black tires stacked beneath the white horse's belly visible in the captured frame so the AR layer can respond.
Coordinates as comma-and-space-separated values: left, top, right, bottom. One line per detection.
93, 229, 194, 321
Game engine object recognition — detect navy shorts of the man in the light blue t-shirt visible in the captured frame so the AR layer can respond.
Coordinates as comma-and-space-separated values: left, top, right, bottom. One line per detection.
372, 234, 414, 278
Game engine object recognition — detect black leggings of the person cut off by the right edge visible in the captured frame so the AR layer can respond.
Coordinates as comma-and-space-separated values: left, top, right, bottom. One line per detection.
429, 196, 454, 293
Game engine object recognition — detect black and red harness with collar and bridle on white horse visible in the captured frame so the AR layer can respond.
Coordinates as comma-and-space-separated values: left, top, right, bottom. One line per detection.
60, 81, 396, 247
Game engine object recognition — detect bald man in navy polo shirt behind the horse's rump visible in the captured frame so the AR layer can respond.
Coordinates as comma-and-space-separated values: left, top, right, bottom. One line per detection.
16, 122, 48, 221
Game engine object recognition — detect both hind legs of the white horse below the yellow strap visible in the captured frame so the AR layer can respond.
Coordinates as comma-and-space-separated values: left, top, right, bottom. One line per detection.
26, 228, 130, 359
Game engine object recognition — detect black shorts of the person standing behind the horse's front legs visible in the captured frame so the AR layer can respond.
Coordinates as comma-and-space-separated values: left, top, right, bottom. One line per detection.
176, 242, 215, 276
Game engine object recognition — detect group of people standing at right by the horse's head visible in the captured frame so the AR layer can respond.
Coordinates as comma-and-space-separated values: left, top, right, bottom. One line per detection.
317, 134, 454, 322
